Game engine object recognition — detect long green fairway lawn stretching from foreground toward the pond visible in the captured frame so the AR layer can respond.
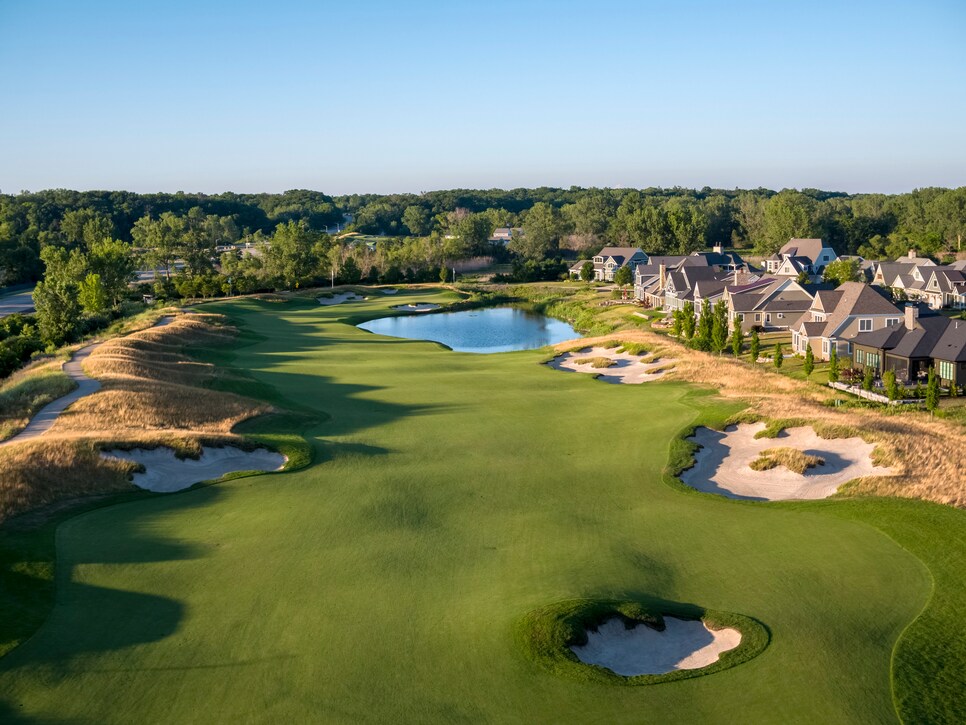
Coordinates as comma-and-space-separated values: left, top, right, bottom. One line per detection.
0, 290, 966, 723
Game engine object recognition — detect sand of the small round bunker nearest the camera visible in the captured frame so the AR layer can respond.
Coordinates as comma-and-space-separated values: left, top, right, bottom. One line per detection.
570, 617, 741, 677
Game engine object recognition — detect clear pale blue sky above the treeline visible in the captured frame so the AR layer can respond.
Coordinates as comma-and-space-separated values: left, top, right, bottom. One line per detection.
0, 0, 966, 194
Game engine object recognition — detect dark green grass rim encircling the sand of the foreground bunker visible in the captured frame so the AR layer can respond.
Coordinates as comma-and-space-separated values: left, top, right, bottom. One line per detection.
517, 599, 770, 685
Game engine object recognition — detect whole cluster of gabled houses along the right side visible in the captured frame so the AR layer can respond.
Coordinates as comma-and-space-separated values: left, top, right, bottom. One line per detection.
570, 239, 966, 385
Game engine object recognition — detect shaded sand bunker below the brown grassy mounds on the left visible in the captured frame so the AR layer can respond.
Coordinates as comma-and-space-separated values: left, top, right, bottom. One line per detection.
101, 447, 286, 493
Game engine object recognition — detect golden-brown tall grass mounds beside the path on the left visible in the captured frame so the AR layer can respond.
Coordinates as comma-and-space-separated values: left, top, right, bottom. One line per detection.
0, 314, 271, 521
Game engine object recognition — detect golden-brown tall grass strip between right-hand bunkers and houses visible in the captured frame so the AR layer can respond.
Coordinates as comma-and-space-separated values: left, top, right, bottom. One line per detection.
557, 330, 966, 507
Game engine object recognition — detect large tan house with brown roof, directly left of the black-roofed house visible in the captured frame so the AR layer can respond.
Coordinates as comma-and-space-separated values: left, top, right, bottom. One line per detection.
792, 282, 902, 360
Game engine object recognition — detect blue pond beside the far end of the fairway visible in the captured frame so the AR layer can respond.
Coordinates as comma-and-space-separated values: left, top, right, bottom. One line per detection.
359, 307, 580, 353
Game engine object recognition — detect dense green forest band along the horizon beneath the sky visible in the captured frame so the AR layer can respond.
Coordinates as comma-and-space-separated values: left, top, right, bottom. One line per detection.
0, 187, 966, 284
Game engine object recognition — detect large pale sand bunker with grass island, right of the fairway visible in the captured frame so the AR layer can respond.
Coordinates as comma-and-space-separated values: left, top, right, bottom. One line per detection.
681, 423, 892, 501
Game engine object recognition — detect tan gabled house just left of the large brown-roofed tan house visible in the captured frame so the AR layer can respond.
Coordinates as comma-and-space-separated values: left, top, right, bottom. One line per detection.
724, 277, 818, 333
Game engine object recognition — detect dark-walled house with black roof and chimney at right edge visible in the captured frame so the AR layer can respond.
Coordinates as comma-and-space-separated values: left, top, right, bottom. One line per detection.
852, 304, 966, 385
